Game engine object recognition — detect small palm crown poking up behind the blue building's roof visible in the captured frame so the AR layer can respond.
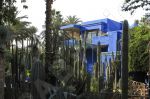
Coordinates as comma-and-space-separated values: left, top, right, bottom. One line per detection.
64, 15, 82, 25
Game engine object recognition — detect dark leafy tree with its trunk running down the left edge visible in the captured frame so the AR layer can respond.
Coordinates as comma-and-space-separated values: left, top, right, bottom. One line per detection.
0, 0, 30, 99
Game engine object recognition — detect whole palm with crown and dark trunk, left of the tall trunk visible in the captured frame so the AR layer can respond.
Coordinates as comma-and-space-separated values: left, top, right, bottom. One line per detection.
8, 16, 37, 96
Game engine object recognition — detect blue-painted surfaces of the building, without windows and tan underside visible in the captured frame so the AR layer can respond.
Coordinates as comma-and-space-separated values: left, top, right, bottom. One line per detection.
61, 18, 122, 72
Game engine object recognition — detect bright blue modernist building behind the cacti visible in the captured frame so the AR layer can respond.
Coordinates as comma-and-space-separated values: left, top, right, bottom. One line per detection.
61, 18, 122, 72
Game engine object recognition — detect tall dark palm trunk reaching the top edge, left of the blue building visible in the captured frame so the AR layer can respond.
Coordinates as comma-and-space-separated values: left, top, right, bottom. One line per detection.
45, 0, 53, 81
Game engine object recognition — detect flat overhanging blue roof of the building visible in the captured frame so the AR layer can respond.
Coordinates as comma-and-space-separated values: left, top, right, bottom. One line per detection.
60, 18, 122, 32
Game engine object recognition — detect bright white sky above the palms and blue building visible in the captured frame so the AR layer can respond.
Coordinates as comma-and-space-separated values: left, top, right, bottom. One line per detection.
17, 0, 144, 33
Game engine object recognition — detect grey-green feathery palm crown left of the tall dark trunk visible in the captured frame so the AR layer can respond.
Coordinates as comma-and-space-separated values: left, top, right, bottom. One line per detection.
10, 21, 37, 74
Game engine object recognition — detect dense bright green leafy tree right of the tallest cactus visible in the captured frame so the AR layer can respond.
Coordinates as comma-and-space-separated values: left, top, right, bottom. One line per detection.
129, 24, 150, 72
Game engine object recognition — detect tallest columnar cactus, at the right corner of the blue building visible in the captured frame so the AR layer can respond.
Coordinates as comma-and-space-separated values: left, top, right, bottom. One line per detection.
121, 20, 128, 99
